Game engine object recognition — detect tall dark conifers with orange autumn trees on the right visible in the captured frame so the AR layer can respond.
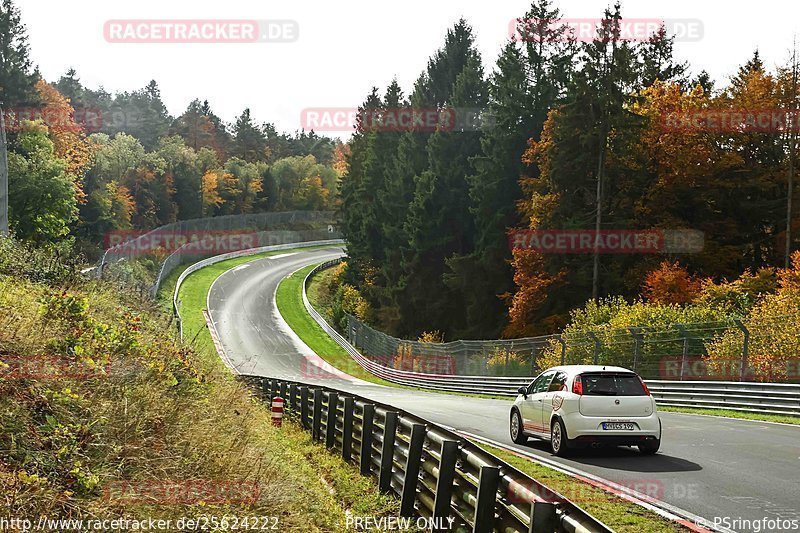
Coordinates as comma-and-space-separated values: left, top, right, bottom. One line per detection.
341, 0, 798, 339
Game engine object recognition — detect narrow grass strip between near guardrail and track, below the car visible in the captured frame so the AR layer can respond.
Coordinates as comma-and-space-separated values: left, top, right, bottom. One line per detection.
475, 442, 686, 533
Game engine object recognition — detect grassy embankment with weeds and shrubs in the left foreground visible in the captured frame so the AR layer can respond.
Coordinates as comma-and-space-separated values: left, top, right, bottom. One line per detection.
0, 240, 397, 532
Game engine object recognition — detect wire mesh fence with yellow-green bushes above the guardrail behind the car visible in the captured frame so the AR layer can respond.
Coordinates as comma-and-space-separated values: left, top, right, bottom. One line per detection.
346, 315, 800, 383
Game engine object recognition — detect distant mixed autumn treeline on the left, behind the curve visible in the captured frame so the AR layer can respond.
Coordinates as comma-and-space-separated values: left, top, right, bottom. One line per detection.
0, 0, 346, 255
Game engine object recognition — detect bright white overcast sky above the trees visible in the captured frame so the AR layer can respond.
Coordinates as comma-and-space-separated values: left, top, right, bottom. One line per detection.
16, 0, 800, 137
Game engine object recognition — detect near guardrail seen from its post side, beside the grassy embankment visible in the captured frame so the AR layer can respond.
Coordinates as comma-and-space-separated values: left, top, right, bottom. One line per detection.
242, 376, 611, 533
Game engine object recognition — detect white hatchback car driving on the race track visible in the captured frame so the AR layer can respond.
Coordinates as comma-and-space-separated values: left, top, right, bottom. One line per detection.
510, 365, 661, 456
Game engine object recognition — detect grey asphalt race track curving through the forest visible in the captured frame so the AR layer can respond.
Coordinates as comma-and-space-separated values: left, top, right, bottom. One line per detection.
208, 248, 800, 531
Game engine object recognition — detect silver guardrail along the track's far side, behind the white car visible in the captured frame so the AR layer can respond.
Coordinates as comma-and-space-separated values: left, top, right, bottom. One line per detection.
303, 259, 800, 416
